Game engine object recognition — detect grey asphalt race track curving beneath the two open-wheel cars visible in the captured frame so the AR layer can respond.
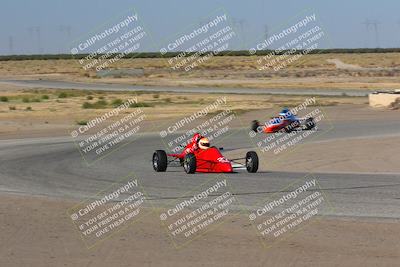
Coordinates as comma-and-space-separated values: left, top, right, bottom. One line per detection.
0, 116, 400, 218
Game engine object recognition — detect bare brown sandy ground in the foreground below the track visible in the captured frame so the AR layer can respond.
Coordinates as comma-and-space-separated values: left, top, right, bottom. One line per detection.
0, 195, 400, 267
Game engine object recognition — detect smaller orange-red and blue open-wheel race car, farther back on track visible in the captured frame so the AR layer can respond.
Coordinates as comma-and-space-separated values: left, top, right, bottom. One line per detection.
251, 109, 316, 133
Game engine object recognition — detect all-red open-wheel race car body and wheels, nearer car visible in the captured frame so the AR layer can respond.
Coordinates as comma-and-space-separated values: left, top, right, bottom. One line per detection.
153, 147, 258, 174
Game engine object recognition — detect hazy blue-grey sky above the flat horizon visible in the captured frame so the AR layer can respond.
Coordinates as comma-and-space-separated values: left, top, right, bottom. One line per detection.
0, 0, 400, 55
